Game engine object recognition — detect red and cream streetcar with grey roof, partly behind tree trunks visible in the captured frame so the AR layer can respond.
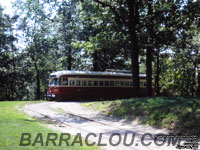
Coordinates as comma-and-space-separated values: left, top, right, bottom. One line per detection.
47, 70, 154, 100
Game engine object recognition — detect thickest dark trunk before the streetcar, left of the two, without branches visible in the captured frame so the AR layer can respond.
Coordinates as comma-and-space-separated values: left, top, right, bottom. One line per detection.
128, 0, 140, 97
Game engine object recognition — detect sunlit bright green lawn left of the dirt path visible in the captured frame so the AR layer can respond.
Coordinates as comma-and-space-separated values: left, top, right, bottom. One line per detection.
0, 101, 98, 150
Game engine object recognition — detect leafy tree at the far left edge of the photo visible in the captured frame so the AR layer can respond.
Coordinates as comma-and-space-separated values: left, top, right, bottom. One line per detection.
0, 7, 27, 100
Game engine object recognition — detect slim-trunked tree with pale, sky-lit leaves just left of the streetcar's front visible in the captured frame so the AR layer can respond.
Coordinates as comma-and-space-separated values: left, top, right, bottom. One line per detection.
15, 0, 60, 99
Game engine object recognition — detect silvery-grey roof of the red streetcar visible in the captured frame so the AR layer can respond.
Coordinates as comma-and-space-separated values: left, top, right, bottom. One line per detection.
50, 70, 146, 78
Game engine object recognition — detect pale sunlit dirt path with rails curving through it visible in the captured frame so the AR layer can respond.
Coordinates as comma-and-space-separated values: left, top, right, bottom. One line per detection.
23, 102, 180, 150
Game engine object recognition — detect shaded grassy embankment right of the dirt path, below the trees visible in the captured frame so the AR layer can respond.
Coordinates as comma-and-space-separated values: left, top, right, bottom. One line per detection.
83, 97, 200, 135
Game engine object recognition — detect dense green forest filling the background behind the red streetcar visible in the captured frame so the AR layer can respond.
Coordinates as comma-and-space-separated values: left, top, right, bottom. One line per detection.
0, 0, 200, 100
